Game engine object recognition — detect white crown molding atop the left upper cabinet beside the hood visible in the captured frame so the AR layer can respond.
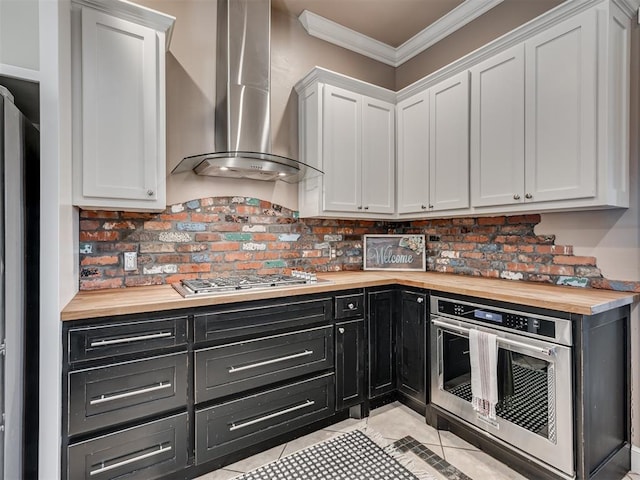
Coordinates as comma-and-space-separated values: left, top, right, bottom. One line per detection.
71, 0, 176, 51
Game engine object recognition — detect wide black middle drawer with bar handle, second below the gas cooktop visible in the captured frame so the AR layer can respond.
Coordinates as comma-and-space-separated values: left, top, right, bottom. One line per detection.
194, 326, 334, 403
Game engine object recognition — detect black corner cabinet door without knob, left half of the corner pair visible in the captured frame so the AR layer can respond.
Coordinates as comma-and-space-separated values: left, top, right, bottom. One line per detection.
367, 290, 396, 398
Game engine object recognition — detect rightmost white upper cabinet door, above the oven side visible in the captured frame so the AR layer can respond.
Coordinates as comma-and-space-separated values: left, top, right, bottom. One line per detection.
525, 10, 596, 202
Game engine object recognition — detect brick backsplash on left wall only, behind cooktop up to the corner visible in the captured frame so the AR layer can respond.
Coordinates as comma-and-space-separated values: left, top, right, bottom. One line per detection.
80, 197, 387, 290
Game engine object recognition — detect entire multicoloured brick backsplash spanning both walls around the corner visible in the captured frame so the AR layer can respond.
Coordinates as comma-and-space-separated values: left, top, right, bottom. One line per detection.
79, 197, 640, 291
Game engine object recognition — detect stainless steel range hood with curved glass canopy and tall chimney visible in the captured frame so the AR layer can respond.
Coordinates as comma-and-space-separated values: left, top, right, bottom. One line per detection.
172, 0, 322, 183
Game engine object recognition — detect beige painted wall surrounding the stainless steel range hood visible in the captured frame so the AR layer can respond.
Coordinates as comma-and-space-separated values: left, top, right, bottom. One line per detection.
136, 0, 395, 210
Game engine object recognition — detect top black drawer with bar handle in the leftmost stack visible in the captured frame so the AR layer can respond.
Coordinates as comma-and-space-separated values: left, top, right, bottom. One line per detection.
69, 317, 187, 363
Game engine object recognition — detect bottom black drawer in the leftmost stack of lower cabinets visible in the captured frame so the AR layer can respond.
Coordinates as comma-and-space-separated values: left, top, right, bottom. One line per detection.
67, 413, 188, 480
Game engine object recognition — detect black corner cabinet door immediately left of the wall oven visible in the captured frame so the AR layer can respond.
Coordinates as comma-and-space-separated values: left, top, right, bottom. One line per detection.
396, 290, 428, 406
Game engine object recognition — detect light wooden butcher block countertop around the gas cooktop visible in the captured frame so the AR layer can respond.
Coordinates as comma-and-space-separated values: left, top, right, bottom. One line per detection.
61, 271, 640, 320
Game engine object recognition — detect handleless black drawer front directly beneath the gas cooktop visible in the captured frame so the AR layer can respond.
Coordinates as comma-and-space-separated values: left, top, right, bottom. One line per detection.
194, 298, 332, 343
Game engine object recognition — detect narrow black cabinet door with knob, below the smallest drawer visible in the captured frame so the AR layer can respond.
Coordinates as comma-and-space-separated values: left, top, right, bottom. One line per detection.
335, 318, 365, 411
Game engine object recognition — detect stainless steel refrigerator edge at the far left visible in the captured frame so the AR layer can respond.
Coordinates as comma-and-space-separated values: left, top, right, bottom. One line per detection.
0, 86, 35, 479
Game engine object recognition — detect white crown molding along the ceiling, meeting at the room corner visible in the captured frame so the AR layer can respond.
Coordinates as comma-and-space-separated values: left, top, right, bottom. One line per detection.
298, 0, 504, 67
